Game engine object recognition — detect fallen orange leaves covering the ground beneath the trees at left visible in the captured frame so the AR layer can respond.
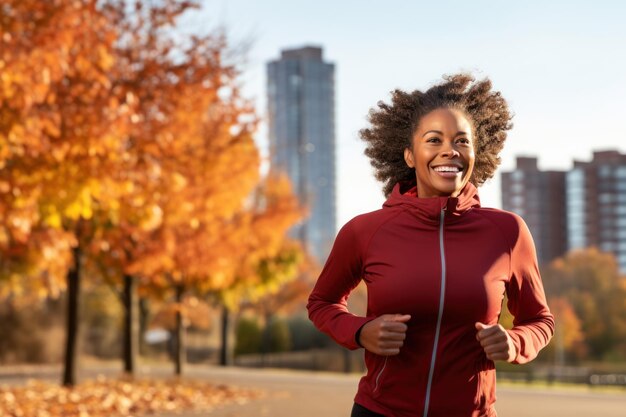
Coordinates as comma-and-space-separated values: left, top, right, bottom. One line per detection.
0, 377, 262, 417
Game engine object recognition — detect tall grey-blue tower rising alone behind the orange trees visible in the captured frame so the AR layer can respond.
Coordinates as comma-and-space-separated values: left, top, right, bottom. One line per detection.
267, 46, 336, 263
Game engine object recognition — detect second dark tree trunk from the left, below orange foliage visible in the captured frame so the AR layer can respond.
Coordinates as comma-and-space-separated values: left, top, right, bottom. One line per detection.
123, 275, 139, 375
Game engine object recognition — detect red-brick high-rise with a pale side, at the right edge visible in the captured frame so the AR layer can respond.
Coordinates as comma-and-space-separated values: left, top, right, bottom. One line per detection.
567, 151, 626, 272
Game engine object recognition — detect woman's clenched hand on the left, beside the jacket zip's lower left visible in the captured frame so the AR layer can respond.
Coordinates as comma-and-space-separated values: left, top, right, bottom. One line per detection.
359, 314, 411, 356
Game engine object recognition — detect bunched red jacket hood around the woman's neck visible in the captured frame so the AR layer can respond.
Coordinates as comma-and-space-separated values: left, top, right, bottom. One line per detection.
383, 182, 480, 222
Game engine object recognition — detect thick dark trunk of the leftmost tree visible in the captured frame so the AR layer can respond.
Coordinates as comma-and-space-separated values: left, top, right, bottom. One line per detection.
63, 246, 80, 387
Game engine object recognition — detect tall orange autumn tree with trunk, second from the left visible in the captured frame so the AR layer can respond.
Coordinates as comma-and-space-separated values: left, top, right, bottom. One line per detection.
83, 1, 258, 373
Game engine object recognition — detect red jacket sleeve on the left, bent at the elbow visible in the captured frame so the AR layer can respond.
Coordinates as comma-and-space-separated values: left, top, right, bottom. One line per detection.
307, 220, 371, 349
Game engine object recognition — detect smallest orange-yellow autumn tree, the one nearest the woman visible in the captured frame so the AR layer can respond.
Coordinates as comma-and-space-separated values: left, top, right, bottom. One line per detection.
211, 174, 307, 365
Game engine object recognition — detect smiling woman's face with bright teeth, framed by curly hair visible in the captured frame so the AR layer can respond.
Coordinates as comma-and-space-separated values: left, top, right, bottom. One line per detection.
404, 108, 475, 197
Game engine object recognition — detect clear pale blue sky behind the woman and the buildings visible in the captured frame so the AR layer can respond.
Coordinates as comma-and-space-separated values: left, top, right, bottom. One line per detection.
185, 0, 626, 228
